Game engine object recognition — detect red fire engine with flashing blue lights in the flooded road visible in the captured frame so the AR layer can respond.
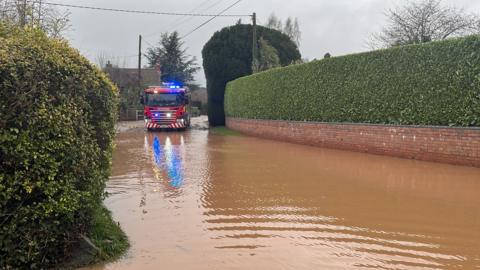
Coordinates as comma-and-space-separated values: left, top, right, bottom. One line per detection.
141, 83, 190, 131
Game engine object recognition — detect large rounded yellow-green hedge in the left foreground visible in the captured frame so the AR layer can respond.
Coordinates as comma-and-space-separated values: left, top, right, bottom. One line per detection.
0, 24, 118, 269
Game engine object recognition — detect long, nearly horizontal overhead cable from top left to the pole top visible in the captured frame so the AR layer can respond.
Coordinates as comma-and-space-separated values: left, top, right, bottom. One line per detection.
39, 2, 251, 17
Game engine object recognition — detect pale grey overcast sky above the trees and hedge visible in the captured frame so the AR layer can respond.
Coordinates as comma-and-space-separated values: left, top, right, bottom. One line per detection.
60, 0, 480, 85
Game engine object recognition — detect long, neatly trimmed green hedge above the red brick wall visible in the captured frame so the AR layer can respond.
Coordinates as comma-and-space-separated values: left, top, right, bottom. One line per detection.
225, 36, 480, 126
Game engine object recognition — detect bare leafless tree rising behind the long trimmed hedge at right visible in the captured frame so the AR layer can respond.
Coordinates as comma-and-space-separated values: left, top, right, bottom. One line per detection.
371, 0, 479, 47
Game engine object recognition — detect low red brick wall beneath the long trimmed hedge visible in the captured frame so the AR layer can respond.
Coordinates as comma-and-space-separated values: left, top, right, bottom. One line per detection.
227, 118, 480, 167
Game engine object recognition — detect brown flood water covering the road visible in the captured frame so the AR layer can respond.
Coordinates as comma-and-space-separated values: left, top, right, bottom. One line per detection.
86, 118, 480, 269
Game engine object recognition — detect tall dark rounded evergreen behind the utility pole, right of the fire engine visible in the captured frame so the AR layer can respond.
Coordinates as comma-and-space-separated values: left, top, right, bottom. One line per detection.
202, 24, 300, 126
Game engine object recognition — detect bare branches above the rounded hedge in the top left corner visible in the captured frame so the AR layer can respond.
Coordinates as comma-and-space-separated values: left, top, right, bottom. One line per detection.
0, 0, 70, 38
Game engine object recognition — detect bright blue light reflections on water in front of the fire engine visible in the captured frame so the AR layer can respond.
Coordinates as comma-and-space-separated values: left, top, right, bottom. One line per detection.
152, 136, 183, 188
